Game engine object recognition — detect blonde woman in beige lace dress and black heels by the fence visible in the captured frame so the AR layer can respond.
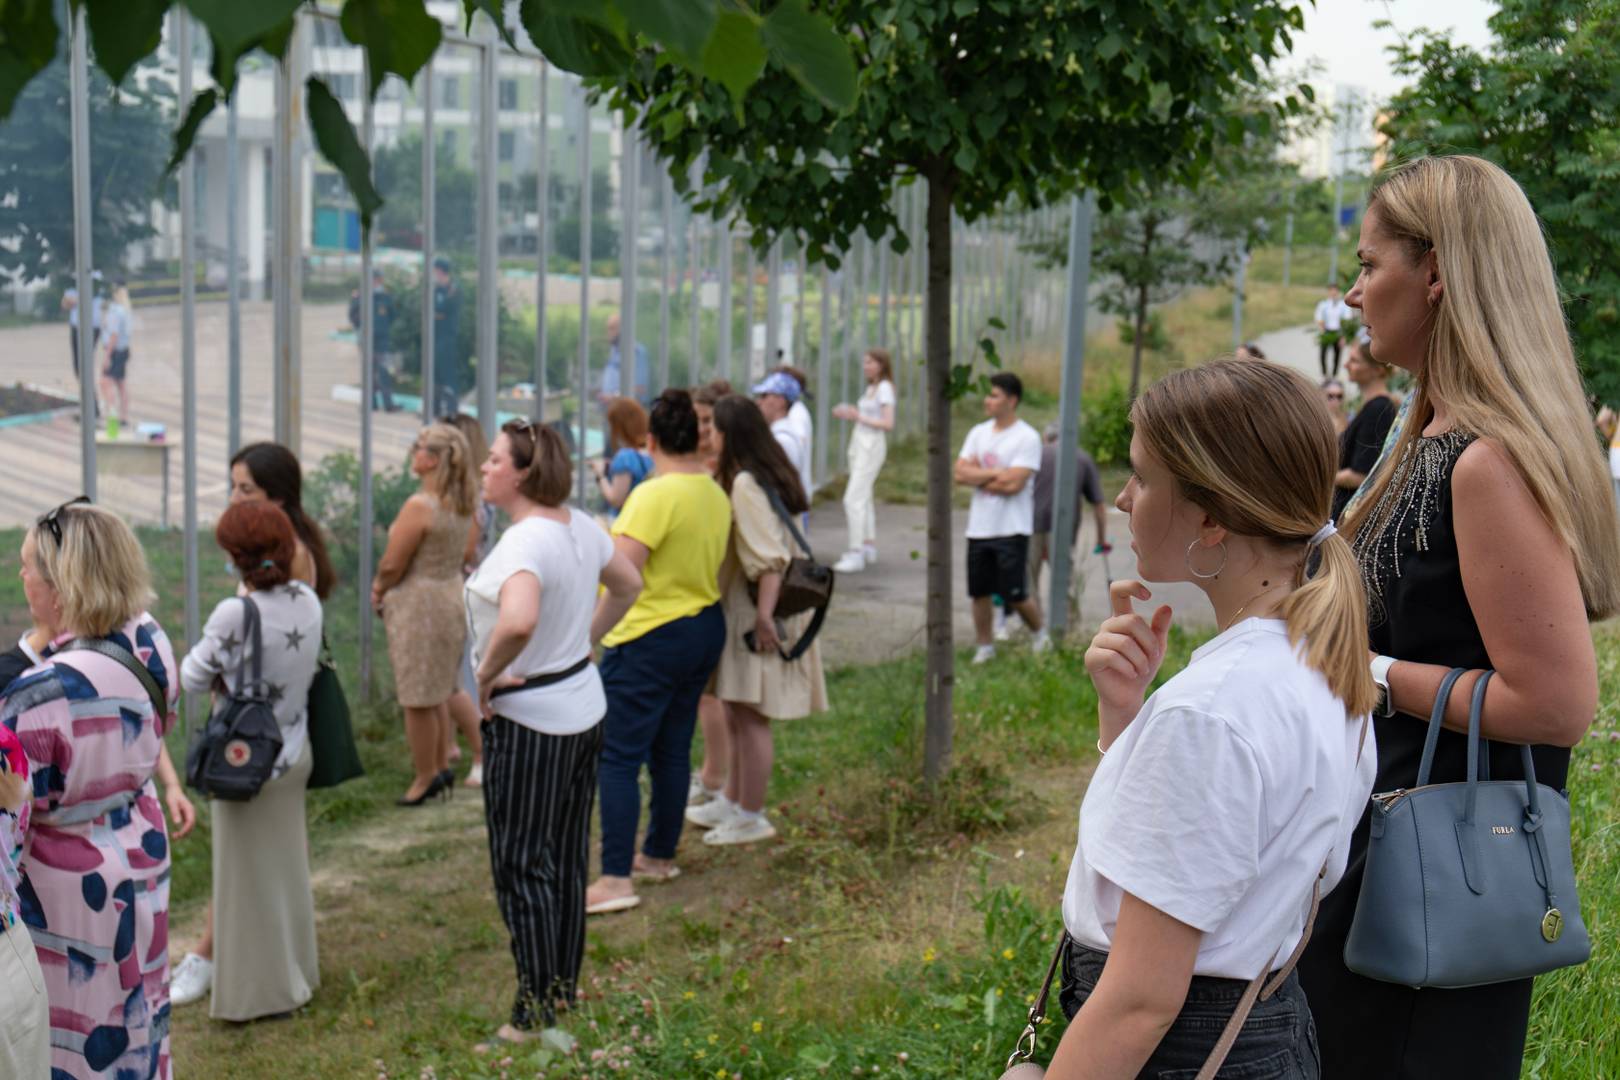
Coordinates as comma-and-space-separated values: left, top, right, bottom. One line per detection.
371, 424, 478, 806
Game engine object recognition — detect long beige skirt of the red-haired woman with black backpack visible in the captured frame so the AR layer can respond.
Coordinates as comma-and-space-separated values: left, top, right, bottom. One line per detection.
209, 743, 321, 1020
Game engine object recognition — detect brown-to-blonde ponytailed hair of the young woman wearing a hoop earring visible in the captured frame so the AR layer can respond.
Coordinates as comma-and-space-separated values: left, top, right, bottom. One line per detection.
1131, 359, 1375, 716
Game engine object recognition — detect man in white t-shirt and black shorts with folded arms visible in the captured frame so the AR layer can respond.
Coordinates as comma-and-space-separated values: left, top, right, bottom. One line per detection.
956, 371, 1050, 664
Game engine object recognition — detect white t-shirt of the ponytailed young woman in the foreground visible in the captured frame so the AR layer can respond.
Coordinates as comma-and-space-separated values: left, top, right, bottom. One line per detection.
1063, 619, 1377, 980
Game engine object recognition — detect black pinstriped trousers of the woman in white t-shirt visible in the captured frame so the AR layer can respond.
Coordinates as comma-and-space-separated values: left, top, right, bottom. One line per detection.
481, 716, 603, 1031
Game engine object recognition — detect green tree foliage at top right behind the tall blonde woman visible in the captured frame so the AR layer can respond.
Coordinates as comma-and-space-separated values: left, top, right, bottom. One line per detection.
1382, 0, 1620, 402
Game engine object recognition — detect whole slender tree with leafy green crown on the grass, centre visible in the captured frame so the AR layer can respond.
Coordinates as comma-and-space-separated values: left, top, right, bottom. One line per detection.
604, 0, 1302, 777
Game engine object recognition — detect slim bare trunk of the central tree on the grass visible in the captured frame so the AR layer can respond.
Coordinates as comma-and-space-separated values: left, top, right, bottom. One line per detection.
922, 164, 956, 787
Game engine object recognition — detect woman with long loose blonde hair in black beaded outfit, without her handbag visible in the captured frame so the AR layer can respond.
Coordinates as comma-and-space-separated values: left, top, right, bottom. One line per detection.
1299, 155, 1620, 1080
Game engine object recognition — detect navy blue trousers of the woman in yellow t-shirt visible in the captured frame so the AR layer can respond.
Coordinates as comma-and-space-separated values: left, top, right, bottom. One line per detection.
596, 604, 726, 878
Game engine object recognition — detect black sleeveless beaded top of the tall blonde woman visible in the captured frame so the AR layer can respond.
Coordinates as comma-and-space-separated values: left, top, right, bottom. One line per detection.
1354, 429, 1570, 792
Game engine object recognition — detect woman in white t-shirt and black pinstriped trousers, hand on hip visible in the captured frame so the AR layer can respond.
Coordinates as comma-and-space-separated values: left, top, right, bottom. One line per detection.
465, 419, 642, 1043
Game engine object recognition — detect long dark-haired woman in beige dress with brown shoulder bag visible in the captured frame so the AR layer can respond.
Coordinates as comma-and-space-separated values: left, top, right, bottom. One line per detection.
687, 395, 826, 845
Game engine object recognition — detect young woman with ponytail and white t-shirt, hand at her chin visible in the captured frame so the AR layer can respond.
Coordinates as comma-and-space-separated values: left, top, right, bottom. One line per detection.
1048, 359, 1375, 1080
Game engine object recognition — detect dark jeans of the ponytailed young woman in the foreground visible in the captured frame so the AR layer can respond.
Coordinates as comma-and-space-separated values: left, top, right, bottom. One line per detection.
1058, 941, 1322, 1080
